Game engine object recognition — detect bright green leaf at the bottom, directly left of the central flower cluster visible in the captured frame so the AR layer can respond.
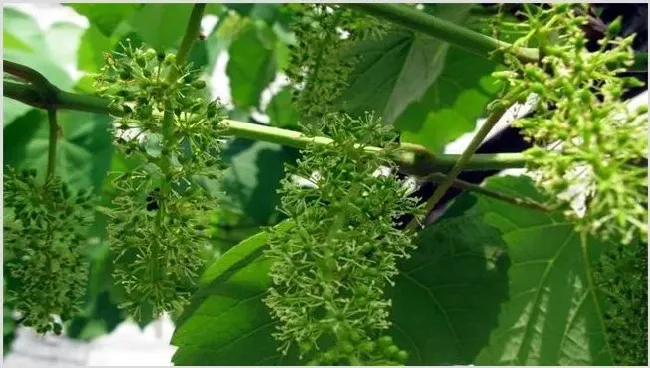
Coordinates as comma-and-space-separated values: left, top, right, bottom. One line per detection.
171, 223, 297, 365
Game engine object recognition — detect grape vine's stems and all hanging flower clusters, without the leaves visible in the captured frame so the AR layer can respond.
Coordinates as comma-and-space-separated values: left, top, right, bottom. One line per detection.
3, 4, 648, 365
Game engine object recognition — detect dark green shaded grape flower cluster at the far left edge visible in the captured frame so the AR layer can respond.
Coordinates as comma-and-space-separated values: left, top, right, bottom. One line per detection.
3, 168, 96, 334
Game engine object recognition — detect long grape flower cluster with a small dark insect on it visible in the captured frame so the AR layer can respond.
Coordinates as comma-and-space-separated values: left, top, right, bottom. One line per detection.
96, 39, 223, 318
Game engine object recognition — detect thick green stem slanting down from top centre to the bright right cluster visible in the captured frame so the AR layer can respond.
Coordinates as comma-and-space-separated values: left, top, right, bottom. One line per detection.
343, 3, 539, 63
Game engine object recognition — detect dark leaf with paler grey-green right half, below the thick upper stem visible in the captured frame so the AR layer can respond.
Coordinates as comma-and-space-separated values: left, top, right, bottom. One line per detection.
341, 4, 471, 124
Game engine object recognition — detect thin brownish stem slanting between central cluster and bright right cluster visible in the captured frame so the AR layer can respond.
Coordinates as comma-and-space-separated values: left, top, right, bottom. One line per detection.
406, 108, 506, 231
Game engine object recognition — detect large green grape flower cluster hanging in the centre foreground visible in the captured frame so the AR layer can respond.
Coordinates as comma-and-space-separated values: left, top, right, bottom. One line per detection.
265, 115, 418, 365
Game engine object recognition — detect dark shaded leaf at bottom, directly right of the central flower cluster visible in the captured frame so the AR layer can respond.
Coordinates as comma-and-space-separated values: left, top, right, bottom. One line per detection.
389, 196, 509, 365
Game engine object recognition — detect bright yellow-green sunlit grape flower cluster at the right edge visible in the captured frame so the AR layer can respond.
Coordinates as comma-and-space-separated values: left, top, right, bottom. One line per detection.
495, 4, 648, 243
